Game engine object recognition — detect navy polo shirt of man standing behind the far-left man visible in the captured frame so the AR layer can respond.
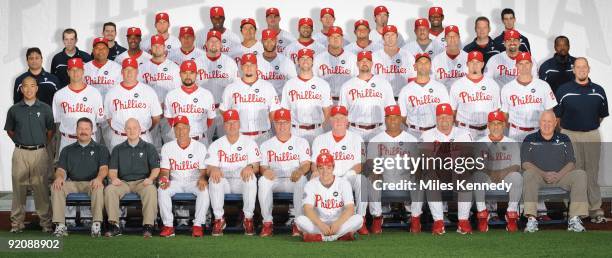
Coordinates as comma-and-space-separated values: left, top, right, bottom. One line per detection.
13, 69, 65, 106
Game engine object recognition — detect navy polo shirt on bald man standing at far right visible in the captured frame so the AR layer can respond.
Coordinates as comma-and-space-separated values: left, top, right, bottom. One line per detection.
553, 79, 609, 132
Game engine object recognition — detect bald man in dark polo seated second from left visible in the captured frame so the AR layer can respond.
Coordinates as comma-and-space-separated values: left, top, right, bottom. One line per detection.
104, 118, 159, 238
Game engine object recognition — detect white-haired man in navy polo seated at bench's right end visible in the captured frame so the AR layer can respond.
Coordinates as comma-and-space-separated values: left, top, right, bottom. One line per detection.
521, 110, 589, 232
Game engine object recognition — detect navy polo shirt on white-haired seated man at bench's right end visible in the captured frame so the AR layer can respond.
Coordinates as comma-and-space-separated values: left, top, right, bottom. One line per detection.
521, 130, 576, 172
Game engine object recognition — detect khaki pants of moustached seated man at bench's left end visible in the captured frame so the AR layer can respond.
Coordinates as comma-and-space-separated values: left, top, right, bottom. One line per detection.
51, 181, 104, 224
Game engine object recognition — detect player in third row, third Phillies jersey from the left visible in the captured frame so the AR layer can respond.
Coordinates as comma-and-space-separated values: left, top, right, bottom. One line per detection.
196, 30, 238, 140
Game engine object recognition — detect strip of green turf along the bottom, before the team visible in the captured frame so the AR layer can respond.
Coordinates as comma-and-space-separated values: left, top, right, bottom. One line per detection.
0, 229, 612, 258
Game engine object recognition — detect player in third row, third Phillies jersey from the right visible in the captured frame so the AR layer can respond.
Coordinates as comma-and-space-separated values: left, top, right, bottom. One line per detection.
372, 25, 416, 100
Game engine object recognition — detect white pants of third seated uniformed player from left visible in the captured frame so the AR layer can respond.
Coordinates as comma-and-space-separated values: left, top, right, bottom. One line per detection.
257, 176, 307, 222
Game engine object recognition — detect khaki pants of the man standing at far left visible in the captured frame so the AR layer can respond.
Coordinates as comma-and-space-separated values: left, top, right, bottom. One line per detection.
11, 148, 52, 228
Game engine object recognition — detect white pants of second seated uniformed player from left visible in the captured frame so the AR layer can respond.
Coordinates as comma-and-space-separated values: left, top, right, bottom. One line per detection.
208, 176, 257, 219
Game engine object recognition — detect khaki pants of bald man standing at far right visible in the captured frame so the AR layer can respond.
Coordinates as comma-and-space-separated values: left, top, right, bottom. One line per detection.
561, 129, 604, 217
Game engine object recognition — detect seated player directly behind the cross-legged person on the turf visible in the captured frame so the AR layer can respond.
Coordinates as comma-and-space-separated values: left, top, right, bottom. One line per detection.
311, 106, 369, 235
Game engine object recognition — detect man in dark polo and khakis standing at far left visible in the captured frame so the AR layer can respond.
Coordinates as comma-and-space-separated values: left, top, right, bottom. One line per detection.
4, 76, 55, 233
